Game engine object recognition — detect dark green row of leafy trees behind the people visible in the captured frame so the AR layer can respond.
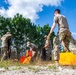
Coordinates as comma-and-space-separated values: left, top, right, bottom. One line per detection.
0, 14, 55, 57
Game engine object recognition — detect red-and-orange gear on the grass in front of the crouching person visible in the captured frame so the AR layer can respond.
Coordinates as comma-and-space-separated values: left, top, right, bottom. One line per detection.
20, 50, 32, 64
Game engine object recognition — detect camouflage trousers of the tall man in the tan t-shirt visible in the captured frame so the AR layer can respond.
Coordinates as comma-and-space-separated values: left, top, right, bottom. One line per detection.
59, 30, 74, 51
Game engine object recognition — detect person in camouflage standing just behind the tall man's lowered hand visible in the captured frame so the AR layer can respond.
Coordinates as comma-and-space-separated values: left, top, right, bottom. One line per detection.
43, 35, 52, 60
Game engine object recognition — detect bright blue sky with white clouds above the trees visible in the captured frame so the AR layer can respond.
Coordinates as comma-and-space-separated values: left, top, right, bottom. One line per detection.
0, 0, 76, 39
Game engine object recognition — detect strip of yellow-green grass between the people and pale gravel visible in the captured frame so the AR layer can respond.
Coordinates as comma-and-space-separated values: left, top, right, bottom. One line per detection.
0, 59, 54, 68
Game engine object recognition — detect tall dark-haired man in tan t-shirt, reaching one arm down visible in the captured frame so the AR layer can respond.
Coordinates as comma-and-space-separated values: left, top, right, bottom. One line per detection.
48, 9, 74, 51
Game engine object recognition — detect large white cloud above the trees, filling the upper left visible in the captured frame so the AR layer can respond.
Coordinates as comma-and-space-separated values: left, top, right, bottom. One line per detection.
0, 0, 63, 22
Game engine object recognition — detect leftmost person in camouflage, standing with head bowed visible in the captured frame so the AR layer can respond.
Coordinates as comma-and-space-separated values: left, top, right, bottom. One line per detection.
1, 32, 12, 61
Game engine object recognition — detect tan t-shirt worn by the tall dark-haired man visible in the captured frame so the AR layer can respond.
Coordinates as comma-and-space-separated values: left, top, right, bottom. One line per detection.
54, 15, 69, 33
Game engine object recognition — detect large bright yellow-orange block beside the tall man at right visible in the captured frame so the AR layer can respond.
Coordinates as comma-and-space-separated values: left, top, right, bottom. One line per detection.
59, 52, 76, 65
